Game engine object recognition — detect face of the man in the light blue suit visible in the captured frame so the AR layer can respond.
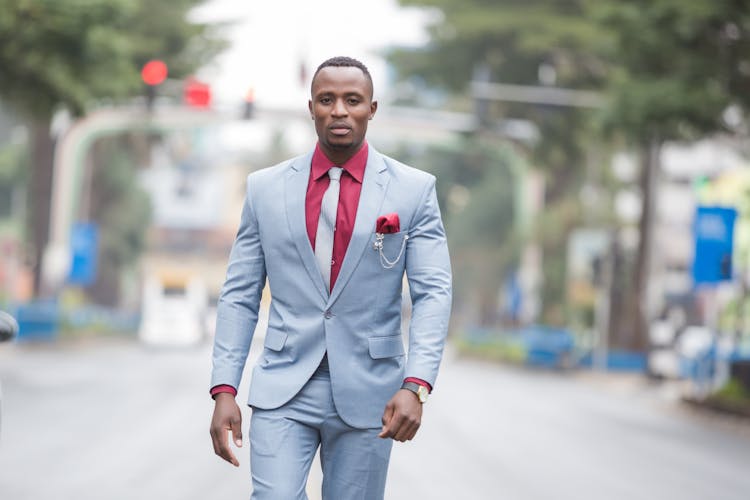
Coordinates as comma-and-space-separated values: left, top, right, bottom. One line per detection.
309, 66, 378, 162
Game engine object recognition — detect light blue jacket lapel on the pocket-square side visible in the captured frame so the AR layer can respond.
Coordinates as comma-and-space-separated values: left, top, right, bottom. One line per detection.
330, 146, 390, 306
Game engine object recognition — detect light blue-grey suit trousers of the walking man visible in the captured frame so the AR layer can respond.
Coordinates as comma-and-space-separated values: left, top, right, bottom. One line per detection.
250, 358, 393, 500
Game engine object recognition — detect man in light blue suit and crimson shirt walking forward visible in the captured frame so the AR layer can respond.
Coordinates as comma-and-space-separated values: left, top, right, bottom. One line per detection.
211, 57, 451, 500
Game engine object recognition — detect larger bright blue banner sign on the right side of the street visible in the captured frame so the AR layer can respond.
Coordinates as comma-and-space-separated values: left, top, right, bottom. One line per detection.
693, 207, 737, 285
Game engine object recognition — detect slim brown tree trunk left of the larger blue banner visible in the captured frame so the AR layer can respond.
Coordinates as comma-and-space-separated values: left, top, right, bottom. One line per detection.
624, 137, 661, 352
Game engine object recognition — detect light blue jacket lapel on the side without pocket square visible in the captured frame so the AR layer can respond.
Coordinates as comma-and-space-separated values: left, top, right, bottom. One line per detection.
284, 153, 328, 299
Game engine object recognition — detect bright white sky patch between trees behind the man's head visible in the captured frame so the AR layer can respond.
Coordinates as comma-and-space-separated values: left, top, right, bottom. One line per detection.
192, 0, 435, 108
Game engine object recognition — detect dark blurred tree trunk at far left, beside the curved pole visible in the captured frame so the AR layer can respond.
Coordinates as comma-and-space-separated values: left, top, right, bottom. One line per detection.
29, 117, 54, 297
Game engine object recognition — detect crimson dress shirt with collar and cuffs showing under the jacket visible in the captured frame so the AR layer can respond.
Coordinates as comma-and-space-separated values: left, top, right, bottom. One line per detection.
211, 142, 432, 396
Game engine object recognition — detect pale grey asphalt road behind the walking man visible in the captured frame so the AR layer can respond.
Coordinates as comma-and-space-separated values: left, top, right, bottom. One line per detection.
0, 340, 750, 500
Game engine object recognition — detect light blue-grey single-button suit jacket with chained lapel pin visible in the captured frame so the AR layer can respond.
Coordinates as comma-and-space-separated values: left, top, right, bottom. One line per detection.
211, 146, 451, 428
